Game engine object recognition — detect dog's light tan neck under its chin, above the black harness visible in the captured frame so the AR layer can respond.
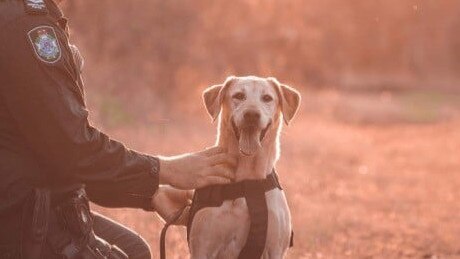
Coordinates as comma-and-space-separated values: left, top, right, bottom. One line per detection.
217, 118, 281, 182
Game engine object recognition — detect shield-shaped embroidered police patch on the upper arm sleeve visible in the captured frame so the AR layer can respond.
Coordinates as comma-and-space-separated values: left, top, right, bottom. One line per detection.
28, 26, 61, 64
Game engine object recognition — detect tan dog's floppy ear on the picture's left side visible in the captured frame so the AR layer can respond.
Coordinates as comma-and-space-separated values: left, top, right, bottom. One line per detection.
203, 76, 235, 121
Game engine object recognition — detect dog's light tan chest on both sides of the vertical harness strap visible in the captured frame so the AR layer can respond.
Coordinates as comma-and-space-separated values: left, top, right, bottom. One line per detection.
190, 189, 291, 258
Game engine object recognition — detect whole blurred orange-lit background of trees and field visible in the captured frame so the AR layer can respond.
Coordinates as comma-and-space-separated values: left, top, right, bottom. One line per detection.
64, 0, 460, 258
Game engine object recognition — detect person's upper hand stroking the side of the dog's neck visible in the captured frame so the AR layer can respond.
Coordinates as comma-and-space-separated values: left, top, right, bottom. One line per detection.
160, 147, 237, 190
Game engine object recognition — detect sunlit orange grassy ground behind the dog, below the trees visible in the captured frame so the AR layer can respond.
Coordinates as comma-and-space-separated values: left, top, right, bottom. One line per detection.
92, 91, 460, 258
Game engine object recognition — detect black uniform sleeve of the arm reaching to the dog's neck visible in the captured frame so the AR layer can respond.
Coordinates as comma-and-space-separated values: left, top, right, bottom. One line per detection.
0, 16, 159, 209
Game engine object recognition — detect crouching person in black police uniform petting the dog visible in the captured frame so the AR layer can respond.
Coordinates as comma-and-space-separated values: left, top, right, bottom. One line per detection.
0, 0, 235, 258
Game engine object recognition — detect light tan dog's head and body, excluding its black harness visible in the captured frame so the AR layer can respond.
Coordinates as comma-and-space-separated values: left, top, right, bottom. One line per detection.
189, 76, 300, 259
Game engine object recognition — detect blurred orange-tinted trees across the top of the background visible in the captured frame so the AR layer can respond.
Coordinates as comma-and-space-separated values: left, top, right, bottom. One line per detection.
62, 0, 460, 106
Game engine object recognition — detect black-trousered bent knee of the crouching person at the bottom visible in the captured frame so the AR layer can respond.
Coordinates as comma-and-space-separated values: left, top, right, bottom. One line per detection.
93, 212, 152, 259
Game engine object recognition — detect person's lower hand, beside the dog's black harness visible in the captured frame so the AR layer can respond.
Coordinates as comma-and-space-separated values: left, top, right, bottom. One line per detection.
152, 186, 193, 226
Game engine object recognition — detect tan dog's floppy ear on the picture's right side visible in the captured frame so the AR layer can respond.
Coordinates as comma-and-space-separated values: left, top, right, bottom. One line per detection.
267, 77, 301, 125
